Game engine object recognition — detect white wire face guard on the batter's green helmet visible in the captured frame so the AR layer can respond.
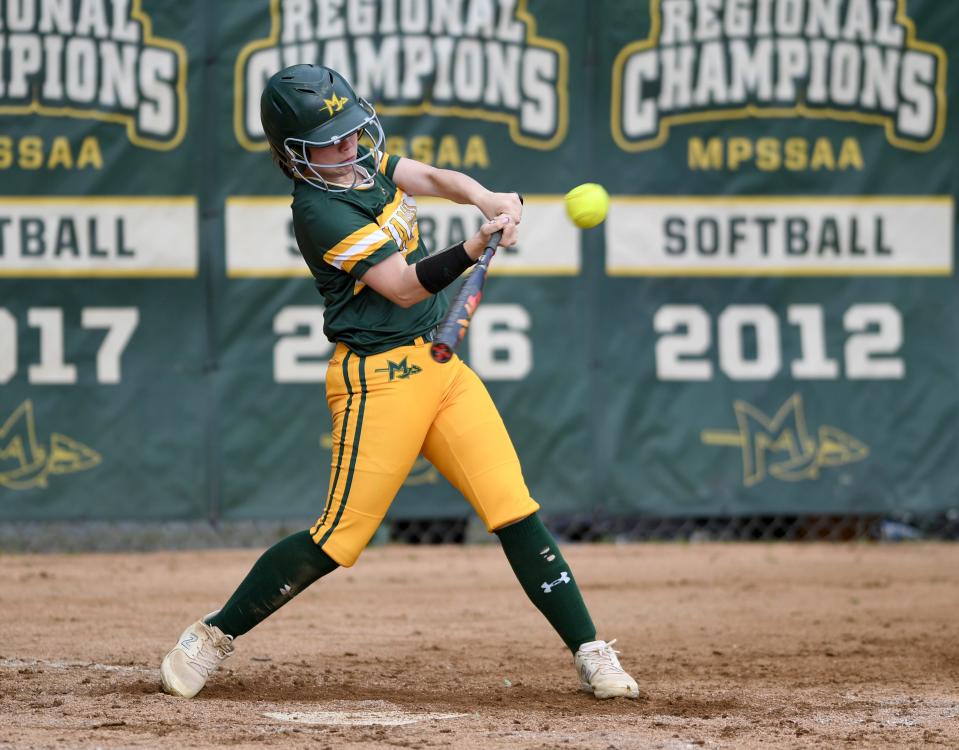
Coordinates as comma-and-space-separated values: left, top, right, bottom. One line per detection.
283, 99, 386, 193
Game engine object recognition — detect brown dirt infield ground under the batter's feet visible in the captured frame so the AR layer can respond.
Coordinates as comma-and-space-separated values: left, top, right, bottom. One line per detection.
0, 544, 959, 750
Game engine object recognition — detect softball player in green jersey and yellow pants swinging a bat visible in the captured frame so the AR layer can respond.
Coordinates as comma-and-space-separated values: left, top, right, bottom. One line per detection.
160, 65, 639, 698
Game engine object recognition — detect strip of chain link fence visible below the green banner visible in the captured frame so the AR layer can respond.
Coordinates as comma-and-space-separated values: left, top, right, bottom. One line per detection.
0, 509, 959, 554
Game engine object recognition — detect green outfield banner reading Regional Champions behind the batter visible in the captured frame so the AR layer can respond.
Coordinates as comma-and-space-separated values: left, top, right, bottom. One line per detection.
0, 0, 959, 525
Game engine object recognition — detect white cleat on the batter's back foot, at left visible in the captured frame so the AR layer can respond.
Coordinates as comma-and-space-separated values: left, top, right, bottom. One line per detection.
160, 612, 233, 698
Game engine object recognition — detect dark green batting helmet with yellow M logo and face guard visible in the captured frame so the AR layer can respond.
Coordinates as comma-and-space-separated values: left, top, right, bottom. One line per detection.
260, 65, 386, 192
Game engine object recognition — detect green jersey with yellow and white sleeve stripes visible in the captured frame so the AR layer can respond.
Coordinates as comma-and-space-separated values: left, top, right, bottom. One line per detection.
293, 147, 448, 355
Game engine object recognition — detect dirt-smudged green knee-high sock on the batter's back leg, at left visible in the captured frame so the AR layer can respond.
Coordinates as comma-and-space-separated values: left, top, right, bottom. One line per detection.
207, 531, 337, 638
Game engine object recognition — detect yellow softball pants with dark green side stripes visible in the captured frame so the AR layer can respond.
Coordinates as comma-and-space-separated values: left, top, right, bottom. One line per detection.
310, 339, 539, 566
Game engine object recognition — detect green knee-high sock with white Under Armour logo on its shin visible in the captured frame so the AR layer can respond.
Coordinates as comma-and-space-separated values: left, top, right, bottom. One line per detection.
496, 513, 596, 653
